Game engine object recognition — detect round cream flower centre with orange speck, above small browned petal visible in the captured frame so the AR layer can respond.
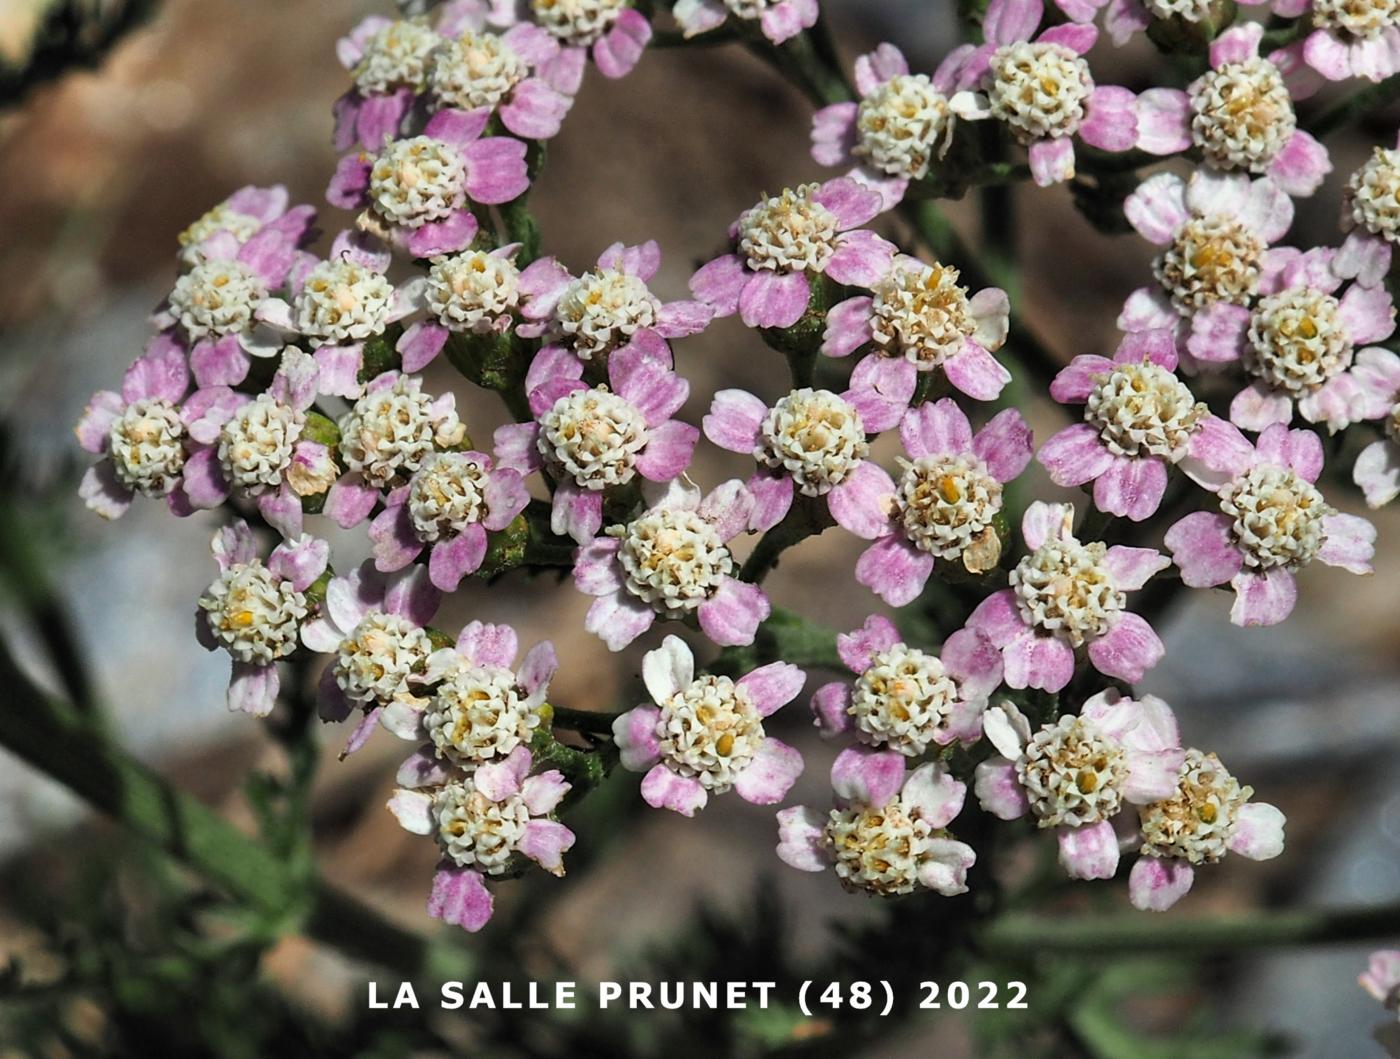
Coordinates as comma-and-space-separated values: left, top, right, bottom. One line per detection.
895, 455, 1001, 559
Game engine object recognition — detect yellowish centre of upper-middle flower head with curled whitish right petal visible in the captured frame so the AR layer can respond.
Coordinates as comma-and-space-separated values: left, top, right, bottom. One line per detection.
871, 265, 977, 371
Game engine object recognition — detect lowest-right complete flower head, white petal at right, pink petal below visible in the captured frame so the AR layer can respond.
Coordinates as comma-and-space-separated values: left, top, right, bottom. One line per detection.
1128, 748, 1284, 912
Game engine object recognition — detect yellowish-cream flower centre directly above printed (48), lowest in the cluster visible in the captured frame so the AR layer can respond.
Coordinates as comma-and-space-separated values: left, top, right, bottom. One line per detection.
823, 798, 935, 897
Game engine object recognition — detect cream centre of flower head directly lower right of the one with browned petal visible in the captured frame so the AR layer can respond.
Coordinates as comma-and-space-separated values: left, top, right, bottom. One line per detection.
1009, 537, 1127, 647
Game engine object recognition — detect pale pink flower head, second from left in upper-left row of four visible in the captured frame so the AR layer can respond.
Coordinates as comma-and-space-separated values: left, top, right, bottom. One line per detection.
258, 231, 426, 398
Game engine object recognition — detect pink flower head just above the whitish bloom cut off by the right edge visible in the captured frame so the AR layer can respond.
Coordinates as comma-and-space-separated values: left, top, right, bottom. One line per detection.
1187, 248, 1396, 433
